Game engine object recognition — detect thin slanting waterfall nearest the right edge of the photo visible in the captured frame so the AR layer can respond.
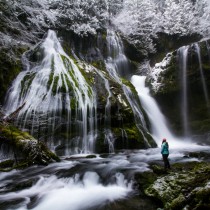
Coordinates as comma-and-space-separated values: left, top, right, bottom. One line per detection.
194, 43, 209, 107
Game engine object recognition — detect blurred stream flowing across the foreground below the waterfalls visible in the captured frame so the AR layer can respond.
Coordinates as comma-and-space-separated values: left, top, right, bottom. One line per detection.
0, 146, 209, 210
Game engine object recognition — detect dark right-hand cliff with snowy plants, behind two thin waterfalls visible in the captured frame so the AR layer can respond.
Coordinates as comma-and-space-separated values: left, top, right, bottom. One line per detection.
147, 40, 210, 139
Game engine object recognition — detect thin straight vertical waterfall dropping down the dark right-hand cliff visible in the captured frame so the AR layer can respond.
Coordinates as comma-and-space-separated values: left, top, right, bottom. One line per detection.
178, 46, 189, 137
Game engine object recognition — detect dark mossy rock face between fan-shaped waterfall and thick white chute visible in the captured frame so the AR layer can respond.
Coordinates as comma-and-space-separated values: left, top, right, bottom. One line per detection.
71, 60, 156, 153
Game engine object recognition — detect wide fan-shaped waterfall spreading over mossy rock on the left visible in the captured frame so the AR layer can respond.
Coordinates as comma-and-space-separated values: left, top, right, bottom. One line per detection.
5, 30, 97, 153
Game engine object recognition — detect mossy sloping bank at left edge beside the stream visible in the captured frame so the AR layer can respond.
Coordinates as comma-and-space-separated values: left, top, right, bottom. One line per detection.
0, 124, 59, 171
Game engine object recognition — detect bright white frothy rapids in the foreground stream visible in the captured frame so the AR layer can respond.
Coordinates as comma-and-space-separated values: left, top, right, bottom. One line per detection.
10, 172, 131, 210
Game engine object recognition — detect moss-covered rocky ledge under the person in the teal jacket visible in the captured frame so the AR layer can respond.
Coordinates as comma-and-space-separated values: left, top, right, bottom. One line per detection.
135, 152, 210, 210
